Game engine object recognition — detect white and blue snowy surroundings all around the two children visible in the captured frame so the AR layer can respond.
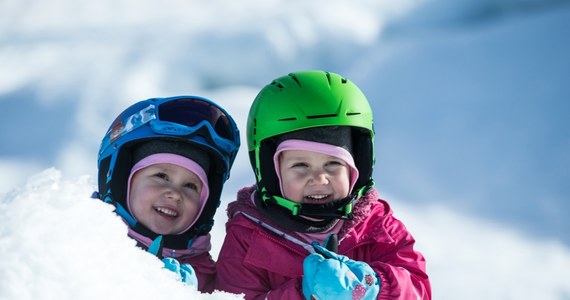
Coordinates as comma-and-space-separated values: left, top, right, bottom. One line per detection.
0, 0, 570, 300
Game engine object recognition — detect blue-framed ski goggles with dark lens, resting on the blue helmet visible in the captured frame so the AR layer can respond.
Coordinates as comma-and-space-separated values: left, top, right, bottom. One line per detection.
109, 98, 239, 154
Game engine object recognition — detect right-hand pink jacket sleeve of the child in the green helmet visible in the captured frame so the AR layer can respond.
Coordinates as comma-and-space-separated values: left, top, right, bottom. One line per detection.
370, 205, 431, 299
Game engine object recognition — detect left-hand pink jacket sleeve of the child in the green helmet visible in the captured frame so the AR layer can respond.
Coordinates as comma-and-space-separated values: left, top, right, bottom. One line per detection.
216, 217, 303, 299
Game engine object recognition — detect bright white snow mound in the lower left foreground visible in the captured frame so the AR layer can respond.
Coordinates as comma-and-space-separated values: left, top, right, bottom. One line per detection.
0, 168, 241, 299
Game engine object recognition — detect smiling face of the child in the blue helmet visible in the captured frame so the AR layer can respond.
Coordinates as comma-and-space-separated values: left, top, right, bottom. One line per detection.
130, 163, 202, 234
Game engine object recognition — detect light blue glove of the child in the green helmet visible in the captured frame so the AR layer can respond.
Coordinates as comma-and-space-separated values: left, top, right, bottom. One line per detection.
303, 244, 380, 300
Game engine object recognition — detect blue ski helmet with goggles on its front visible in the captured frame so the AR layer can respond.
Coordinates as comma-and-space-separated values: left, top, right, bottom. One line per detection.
97, 96, 240, 249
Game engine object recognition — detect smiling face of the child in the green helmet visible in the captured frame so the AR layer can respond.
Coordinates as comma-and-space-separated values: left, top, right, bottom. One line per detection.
279, 150, 350, 204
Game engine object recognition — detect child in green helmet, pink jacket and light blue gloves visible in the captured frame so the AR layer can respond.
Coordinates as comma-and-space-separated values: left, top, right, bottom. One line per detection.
216, 71, 431, 299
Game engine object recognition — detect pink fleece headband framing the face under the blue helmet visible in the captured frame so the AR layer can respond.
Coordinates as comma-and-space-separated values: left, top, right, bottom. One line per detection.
127, 153, 210, 234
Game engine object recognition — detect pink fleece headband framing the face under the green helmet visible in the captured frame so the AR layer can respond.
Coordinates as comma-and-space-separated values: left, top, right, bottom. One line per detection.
273, 139, 358, 194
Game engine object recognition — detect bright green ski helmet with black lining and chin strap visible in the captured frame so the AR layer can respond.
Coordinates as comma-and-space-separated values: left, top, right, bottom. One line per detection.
247, 71, 374, 230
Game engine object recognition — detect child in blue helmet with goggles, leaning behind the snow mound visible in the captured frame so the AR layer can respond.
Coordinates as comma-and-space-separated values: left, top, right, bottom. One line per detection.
94, 96, 240, 292
